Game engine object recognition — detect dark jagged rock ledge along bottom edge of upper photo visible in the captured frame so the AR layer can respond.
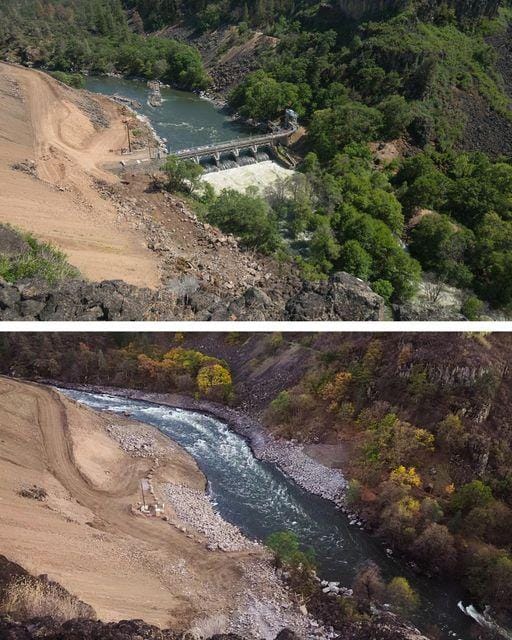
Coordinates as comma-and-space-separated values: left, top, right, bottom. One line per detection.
0, 273, 385, 321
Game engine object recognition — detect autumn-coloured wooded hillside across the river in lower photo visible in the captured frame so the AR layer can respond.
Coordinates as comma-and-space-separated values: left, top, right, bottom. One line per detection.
2, 334, 512, 632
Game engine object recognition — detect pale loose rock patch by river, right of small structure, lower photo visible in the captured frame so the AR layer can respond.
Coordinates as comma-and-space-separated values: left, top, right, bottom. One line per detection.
161, 483, 257, 551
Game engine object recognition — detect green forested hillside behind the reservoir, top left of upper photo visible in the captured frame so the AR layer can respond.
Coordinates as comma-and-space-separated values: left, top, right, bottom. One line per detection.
0, 0, 208, 89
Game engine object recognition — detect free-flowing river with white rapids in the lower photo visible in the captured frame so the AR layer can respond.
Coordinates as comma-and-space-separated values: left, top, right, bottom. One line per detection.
61, 389, 480, 640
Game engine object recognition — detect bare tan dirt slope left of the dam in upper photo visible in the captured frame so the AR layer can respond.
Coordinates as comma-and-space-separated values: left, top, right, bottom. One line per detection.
0, 63, 160, 287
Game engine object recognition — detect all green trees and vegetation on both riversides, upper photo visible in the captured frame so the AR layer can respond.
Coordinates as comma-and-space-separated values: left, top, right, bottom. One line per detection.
0, 0, 512, 319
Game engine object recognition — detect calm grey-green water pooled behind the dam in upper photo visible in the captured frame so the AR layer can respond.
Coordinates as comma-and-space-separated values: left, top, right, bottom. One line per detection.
86, 76, 250, 151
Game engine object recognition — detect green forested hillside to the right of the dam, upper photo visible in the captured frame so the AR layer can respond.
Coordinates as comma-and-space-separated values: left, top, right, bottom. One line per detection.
127, 0, 512, 318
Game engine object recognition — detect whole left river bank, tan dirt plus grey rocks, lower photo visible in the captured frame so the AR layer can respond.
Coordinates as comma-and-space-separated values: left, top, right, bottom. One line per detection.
0, 377, 324, 640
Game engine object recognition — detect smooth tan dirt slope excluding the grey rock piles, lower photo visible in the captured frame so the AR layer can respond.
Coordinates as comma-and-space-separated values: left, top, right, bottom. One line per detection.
0, 378, 268, 629
